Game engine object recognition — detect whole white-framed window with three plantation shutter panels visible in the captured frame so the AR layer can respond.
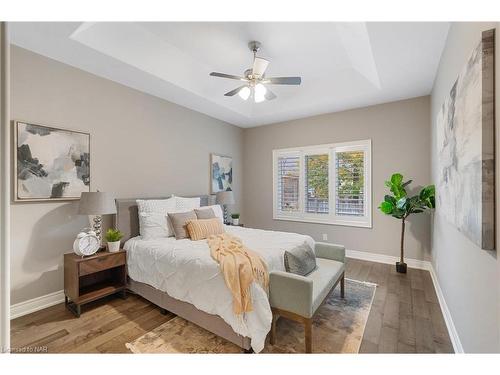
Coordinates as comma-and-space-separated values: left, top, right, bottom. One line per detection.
273, 140, 371, 227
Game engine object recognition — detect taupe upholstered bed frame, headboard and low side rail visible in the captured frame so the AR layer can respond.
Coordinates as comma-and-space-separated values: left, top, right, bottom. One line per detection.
114, 195, 251, 351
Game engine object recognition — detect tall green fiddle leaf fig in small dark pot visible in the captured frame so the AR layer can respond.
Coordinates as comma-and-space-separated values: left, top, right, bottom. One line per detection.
379, 173, 436, 273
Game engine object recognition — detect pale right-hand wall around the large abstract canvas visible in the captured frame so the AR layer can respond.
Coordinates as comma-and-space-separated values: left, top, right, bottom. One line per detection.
431, 22, 500, 352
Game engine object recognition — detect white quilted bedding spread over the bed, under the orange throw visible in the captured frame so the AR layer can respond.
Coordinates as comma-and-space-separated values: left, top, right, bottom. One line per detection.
124, 226, 314, 353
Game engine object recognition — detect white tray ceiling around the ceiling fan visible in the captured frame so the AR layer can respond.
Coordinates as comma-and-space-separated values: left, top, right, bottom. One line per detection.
11, 22, 449, 127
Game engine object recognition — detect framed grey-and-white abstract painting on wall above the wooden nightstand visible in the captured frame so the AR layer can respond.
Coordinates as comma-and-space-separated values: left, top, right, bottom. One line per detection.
14, 121, 90, 202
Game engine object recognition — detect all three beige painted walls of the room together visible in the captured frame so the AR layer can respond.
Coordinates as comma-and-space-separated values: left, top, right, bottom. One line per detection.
11, 23, 500, 352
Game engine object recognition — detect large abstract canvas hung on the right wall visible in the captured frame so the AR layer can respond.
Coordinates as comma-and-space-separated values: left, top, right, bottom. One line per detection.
436, 30, 495, 250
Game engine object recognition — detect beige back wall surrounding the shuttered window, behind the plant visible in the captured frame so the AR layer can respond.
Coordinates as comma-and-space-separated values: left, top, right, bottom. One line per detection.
241, 97, 430, 259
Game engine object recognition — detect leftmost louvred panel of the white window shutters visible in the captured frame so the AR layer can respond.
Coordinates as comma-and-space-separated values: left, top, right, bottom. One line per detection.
277, 155, 300, 212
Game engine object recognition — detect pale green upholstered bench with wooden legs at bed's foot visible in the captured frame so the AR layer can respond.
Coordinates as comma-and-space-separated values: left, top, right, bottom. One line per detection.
269, 242, 345, 353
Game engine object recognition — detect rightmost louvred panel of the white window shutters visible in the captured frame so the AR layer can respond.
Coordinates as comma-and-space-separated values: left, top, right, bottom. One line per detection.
335, 150, 365, 216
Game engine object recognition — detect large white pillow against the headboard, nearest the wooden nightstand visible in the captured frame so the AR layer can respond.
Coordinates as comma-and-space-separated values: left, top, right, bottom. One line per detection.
136, 198, 175, 240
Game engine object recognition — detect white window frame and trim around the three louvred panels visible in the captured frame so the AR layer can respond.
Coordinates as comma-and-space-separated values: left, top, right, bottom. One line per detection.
272, 139, 372, 228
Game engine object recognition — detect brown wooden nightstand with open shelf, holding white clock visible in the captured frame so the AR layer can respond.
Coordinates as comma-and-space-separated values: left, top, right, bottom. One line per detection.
64, 250, 127, 317
